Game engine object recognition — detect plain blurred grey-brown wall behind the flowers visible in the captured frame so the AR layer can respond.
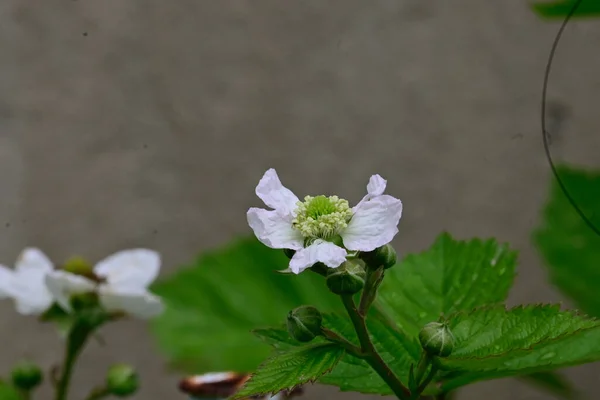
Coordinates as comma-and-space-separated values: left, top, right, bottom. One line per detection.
0, 0, 600, 400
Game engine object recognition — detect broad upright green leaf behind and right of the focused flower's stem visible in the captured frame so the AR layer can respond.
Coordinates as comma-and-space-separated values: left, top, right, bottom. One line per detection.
377, 233, 517, 337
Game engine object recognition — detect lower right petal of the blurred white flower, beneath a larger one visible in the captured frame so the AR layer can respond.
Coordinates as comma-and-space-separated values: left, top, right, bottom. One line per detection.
100, 286, 164, 319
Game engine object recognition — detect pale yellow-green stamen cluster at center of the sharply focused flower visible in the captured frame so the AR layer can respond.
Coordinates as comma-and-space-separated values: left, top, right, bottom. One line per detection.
292, 196, 352, 239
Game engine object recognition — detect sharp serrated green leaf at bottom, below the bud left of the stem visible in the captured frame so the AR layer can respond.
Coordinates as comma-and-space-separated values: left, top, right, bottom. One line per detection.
234, 343, 344, 399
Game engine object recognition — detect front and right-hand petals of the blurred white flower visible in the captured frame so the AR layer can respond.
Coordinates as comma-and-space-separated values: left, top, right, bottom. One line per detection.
46, 249, 163, 318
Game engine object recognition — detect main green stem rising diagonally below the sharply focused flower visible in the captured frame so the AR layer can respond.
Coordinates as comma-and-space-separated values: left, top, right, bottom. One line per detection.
341, 295, 411, 400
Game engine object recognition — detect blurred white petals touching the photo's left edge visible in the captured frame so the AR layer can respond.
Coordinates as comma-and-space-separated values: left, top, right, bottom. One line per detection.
0, 247, 54, 315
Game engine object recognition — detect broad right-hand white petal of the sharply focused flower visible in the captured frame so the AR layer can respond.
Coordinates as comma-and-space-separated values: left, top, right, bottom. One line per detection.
342, 195, 402, 251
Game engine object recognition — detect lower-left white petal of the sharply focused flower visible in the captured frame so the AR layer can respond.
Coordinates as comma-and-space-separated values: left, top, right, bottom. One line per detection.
246, 207, 303, 250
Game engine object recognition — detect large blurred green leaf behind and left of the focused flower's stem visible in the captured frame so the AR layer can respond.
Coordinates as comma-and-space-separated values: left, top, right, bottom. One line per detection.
152, 237, 339, 374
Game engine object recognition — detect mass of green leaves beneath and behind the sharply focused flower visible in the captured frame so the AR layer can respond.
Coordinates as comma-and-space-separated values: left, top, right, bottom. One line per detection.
154, 230, 600, 395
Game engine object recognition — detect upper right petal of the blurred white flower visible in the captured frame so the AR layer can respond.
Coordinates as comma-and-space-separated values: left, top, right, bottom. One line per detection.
94, 249, 160, 289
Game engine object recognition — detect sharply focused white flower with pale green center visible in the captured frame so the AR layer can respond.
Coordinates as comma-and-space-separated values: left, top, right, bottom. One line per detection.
247, 169, 402, 274
